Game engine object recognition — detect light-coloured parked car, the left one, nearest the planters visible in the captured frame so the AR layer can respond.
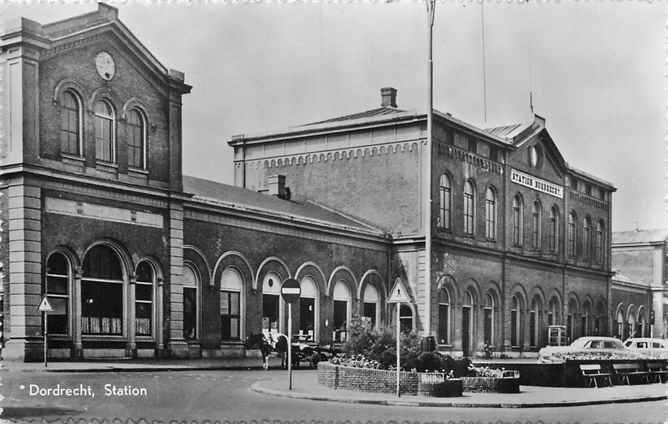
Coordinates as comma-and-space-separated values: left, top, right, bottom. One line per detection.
538, 336, 644, 363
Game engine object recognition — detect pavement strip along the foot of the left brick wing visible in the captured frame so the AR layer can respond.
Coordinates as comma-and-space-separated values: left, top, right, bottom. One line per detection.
0, 357, 281, 372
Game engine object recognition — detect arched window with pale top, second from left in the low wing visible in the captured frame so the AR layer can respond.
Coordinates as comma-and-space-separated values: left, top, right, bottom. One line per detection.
220, 268, 244, 340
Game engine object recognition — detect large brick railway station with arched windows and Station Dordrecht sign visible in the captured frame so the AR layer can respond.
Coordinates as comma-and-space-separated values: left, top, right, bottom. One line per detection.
0, 3, 615, 360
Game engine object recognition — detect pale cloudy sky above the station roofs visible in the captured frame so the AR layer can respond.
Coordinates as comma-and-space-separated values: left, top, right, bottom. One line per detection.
0, 0, 668, 231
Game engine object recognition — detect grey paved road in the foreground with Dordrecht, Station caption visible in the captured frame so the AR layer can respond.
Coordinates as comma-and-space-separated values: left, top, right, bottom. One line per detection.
0, 371, 668, 424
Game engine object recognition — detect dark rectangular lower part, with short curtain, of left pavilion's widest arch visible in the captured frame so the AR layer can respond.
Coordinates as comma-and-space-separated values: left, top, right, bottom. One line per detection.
81, 281, 123, 335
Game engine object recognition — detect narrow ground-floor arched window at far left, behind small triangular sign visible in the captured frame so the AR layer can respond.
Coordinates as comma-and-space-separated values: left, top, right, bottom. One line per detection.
44, 253, 72, 334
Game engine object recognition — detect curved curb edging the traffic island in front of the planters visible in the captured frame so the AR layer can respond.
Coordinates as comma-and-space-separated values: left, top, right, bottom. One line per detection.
250, 382, 668, 408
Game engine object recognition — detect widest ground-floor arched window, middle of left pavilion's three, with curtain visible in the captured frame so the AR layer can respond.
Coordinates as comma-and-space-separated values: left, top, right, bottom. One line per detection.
81, 245, 125, 335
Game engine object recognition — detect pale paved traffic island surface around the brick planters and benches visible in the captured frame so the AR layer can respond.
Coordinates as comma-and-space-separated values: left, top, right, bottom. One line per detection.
251, 371, 668, 408
